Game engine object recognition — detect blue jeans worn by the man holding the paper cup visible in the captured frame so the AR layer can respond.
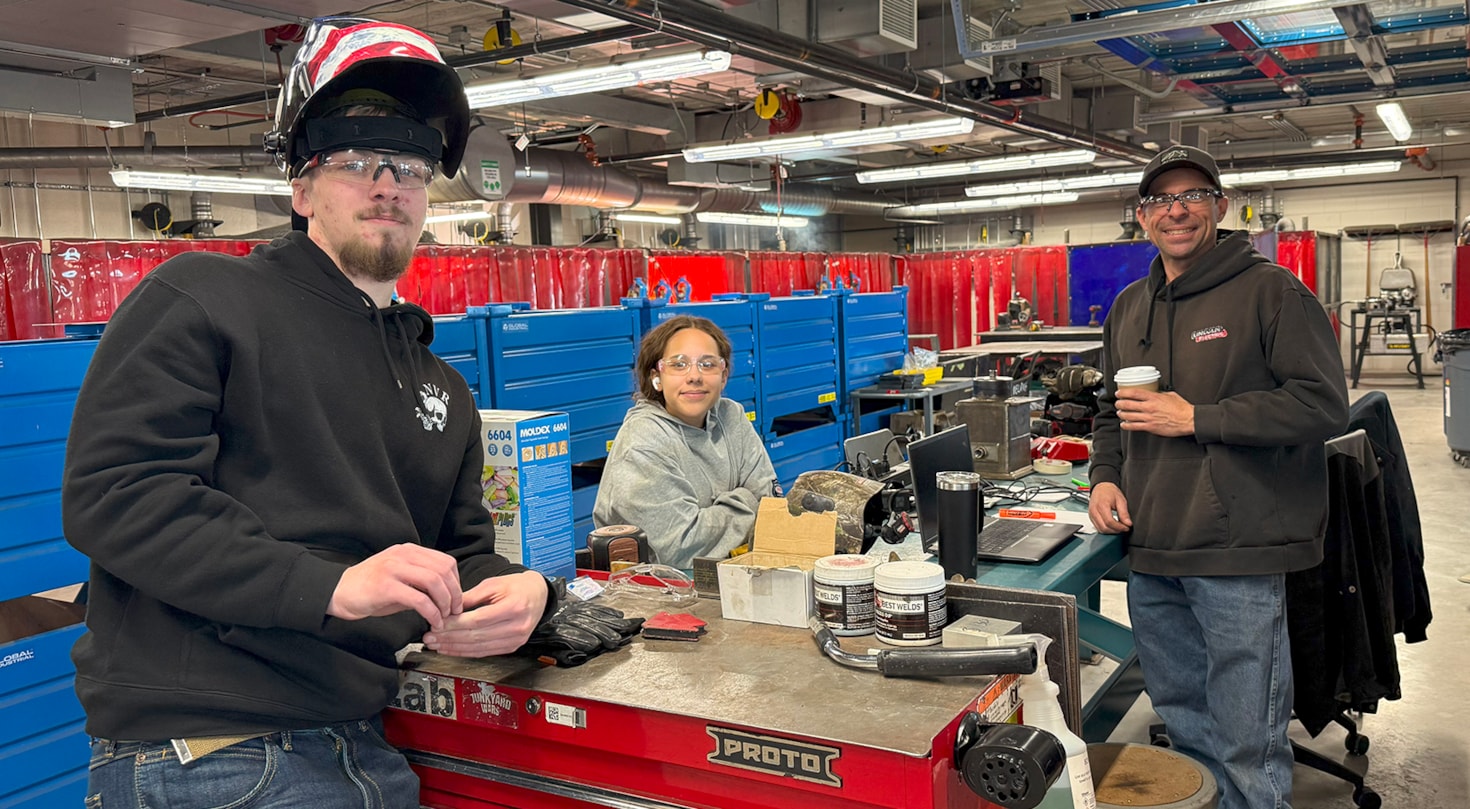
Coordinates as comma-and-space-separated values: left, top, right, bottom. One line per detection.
1127, 574, 1292, 809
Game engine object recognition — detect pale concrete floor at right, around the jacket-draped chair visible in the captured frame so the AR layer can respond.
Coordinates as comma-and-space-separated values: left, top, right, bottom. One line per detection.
1083, 374, 1470, 809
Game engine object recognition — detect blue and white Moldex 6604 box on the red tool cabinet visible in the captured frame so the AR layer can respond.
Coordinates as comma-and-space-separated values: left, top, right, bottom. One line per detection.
479, 410, 576, 581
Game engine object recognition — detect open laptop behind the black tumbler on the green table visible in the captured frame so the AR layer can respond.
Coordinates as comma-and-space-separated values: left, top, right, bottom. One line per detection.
908, 424, 1082, 565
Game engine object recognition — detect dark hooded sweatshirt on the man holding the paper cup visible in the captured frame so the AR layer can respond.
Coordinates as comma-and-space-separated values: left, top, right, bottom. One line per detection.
1091, 231, 1348, 575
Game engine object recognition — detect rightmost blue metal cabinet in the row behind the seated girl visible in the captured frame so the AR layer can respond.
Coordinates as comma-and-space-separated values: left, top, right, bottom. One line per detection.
838, 287, 908, 437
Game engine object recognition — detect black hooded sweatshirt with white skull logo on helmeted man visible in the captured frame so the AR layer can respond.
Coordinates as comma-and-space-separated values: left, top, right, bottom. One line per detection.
62, 232, 522, 740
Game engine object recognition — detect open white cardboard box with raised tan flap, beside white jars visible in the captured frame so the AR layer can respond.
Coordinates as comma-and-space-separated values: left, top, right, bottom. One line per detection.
716, 497, 836, 628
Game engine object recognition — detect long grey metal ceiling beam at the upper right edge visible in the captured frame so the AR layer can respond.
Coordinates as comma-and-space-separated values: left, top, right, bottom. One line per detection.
978, 0, 1363, 56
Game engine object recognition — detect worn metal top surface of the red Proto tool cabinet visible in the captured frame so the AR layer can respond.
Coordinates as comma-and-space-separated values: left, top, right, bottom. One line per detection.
404, 599, 994, 756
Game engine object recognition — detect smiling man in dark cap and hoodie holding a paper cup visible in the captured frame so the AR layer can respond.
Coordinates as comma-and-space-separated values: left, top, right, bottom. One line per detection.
1089, 147, 1348, 809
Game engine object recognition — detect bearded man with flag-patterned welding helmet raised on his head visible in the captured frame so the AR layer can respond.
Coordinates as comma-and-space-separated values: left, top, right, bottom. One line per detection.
62, 18, 554, 809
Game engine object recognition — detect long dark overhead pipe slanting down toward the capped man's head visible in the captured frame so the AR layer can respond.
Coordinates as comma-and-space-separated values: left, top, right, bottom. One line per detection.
562, 0, 1152, 163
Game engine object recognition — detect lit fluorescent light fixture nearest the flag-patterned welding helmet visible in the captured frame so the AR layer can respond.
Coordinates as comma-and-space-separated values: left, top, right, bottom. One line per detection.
465, 50, 731, 109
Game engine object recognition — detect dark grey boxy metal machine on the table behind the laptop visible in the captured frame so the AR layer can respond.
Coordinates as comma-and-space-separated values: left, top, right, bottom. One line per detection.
954, 374, 1044, 481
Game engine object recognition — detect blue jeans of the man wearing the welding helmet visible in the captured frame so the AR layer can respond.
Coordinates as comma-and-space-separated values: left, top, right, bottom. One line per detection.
87, 719, 419, 809
